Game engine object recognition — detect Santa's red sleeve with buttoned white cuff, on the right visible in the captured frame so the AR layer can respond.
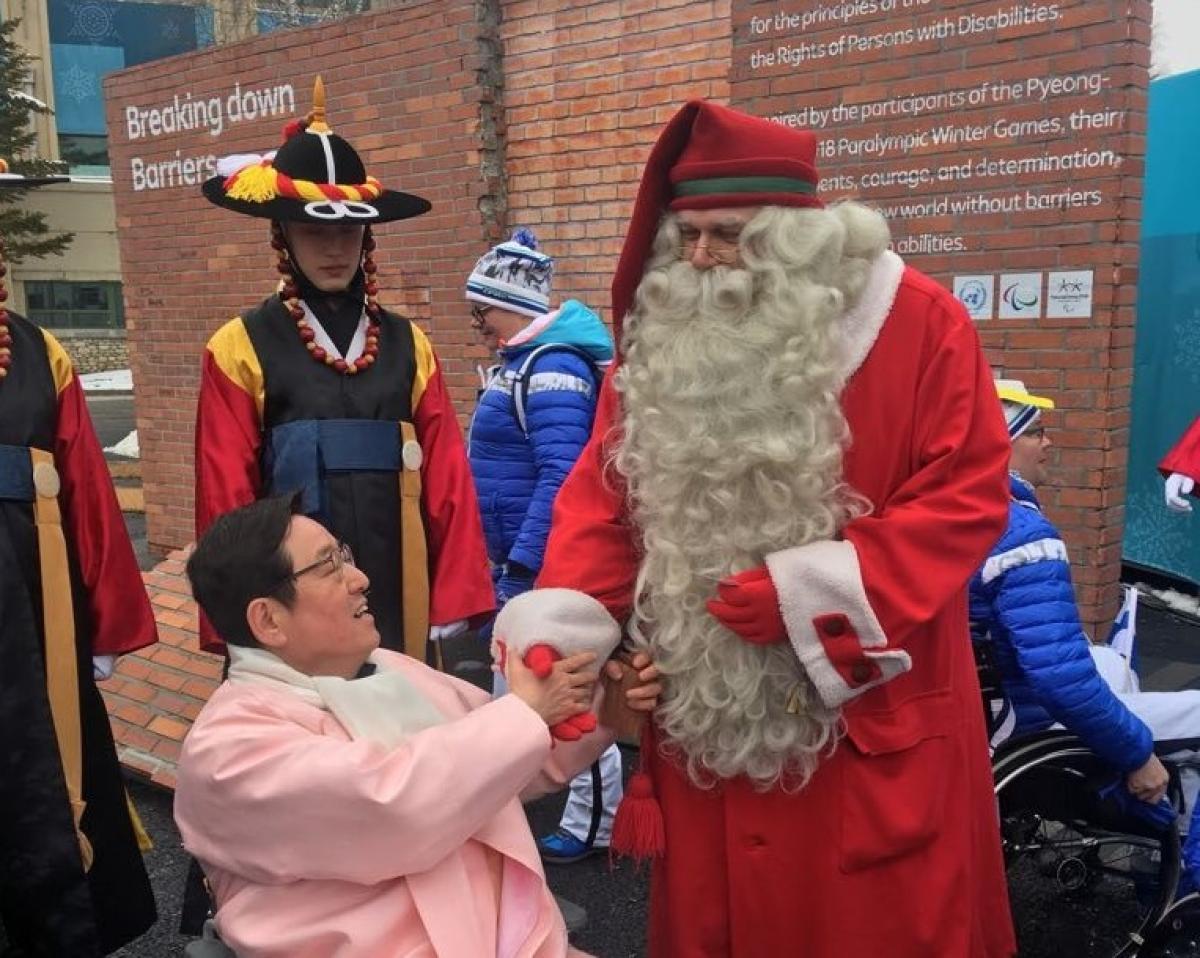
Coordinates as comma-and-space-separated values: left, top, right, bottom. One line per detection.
767, 317, 1010, 707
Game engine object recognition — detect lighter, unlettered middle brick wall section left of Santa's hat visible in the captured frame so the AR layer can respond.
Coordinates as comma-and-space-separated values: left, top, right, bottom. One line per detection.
500, 0, 730, 318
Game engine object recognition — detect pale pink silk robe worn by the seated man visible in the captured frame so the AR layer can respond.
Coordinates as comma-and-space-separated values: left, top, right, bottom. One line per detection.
175, 653, 612, 958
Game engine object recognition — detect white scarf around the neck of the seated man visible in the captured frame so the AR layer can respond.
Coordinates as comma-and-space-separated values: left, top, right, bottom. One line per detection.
229, 645, 445, 748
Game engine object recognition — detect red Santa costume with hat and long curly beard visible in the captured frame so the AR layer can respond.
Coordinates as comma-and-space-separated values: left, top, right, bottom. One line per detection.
539, 102, 1014, 958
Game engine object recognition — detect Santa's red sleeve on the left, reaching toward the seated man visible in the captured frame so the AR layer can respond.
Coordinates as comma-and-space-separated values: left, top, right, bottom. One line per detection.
538, 371, 640, 622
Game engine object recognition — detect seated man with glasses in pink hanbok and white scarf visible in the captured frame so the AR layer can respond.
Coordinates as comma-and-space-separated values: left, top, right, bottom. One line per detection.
175, 498, 658, 958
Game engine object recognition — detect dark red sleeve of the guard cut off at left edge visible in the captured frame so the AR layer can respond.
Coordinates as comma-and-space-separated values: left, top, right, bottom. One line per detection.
54, 375, 158, 655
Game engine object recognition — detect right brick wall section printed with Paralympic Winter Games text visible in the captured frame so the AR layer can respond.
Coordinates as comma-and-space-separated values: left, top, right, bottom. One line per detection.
731, 0, 1151, 637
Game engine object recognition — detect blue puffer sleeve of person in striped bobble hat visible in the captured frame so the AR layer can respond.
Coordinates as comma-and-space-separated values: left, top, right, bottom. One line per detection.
508, 353, 596, 573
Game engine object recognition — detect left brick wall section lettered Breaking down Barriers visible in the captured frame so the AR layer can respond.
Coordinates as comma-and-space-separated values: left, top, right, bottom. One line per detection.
106, 0, 511, 551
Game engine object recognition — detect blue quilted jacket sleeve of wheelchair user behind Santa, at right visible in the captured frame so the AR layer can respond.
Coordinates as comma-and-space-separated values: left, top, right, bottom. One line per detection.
991, 550, 1154, 772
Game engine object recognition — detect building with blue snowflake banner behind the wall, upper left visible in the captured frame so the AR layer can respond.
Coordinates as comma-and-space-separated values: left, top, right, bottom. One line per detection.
0, 0, 370, 372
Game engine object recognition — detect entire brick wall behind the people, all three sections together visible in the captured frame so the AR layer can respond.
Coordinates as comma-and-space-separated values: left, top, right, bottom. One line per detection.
107, 0, 1150, 625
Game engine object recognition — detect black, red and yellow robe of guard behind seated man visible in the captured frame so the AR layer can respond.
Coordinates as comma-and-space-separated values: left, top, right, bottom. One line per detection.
196, 297, 493, 658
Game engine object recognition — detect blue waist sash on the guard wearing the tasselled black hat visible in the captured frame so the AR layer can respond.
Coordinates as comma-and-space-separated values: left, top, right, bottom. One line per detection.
262, 419, 401, 517
